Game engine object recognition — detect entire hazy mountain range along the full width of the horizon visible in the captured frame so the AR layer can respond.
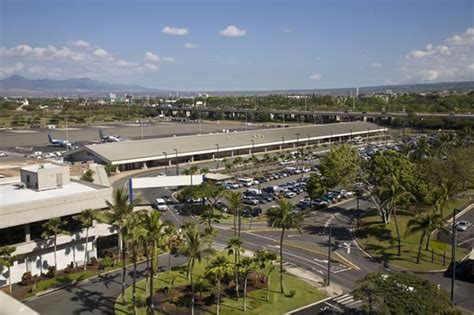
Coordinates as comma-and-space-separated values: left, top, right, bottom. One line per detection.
0, 75, 474, 97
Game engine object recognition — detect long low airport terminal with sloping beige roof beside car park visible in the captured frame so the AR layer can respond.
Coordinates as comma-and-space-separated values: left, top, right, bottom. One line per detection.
64, 122, 387, 171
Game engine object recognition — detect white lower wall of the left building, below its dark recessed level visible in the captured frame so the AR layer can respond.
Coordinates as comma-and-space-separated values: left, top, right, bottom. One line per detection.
0, 224, 116, 287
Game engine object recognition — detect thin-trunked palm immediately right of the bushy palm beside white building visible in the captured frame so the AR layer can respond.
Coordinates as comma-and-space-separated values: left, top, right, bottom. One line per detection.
127, 212, 147, 314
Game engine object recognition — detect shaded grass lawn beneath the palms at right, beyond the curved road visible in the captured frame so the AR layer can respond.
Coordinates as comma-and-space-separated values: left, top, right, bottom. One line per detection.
357, 199, 467, 271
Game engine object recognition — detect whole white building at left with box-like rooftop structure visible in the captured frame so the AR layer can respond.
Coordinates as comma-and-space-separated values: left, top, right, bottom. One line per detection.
0, 163, 115, 286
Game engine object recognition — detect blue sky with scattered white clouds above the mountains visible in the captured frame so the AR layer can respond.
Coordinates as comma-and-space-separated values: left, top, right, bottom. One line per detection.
0, 0, 474, 92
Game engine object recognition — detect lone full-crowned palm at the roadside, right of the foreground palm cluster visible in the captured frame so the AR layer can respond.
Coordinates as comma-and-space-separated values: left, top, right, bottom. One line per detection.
268, 198, 303, 293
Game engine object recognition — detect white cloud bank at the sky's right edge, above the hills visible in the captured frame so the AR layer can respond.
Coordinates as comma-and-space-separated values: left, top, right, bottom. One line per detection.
400, 27, 474, 82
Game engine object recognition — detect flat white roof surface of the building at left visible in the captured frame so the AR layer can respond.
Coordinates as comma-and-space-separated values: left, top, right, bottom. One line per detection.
0, 182, 97, 209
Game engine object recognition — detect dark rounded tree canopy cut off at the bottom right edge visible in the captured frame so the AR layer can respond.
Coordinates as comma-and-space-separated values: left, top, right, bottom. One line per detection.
353, 272, 459, 315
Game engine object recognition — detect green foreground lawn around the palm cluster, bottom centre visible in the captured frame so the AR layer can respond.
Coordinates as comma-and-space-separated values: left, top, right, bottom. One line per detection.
115, 253, 326, 315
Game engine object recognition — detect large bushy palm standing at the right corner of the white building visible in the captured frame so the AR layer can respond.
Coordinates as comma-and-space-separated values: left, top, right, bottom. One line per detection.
99, 189, 133, 303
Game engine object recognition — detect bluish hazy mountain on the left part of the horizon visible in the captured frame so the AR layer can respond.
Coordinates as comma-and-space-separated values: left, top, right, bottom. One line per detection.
0, 75, 164, 96
